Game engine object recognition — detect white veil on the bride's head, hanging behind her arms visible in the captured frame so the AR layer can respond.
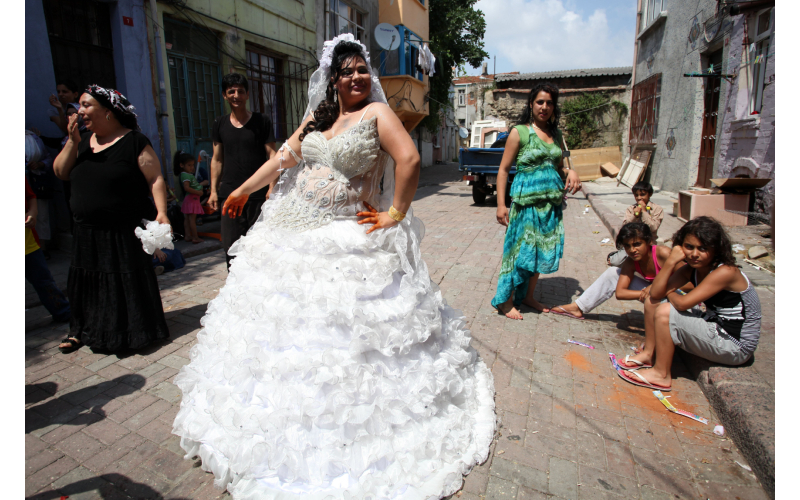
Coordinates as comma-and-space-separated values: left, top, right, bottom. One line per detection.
267, 33, 394, 211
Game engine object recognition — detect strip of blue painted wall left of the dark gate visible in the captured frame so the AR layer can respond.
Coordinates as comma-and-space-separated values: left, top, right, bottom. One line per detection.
25, 0, 62, 137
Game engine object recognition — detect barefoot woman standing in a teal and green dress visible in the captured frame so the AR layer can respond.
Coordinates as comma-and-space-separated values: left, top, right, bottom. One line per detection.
492, 83, 581, 319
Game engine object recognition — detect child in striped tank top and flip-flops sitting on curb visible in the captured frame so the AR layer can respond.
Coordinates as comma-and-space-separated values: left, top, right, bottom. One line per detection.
618, 217, 761, 391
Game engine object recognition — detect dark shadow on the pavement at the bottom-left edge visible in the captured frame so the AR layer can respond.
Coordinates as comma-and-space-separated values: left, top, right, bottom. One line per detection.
26, 474, 194, 500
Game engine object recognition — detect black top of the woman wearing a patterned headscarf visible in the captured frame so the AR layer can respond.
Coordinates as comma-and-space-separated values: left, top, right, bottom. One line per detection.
69, 130, 157, 229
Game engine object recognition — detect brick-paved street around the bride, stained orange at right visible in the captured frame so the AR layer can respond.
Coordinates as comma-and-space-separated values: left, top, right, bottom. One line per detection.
25, 165, 775, 500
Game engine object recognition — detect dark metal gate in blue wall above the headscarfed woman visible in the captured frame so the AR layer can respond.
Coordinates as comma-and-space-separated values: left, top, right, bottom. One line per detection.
43, 0, 117, 88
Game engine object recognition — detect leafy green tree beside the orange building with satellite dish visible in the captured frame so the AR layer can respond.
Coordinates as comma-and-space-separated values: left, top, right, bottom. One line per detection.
420, 0, 489, 133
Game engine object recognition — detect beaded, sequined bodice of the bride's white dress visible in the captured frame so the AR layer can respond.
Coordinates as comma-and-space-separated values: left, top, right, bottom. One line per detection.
272, 117, 383, 231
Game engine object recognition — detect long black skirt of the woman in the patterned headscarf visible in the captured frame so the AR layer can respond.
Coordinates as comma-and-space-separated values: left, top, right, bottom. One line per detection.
67, 224, 169, 351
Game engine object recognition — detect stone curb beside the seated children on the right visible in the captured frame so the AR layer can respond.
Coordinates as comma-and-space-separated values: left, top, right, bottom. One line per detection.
581, 187, 775, 498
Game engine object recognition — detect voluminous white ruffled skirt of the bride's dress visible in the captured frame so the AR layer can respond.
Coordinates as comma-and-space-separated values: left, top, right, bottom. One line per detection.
173, 215, 495, 499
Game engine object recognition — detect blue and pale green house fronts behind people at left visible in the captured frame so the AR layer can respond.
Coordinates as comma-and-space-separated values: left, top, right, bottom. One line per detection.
25, 0, 317, 188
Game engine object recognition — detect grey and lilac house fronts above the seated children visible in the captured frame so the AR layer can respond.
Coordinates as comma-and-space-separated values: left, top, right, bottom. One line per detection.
628, 0, 775, 211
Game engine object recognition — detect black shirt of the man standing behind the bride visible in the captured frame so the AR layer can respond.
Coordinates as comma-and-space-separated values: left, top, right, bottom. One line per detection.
211, 113, 275, 200
